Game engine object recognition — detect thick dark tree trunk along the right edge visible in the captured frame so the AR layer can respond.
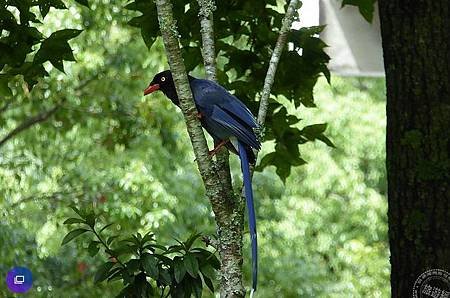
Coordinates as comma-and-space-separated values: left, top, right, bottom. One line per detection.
379, 0, 450, 297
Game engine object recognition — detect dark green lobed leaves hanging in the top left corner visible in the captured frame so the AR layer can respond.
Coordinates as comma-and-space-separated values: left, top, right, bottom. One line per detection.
0, 0, 87, 89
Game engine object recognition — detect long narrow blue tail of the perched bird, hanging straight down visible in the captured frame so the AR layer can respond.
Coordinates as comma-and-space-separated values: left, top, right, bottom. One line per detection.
238, 142, 258, 294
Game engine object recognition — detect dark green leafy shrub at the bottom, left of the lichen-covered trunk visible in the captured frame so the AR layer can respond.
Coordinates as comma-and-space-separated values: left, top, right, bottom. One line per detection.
62, 206, 220, 297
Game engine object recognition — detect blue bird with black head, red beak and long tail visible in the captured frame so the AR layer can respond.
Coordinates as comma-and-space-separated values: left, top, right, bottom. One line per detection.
144, 70, 261, 293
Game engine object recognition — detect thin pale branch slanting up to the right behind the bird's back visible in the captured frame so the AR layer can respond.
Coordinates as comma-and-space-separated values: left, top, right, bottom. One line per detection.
258, 0, 300, 126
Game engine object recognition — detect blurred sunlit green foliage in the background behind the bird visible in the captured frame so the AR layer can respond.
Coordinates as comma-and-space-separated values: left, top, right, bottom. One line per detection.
0, 1, 389, 297
